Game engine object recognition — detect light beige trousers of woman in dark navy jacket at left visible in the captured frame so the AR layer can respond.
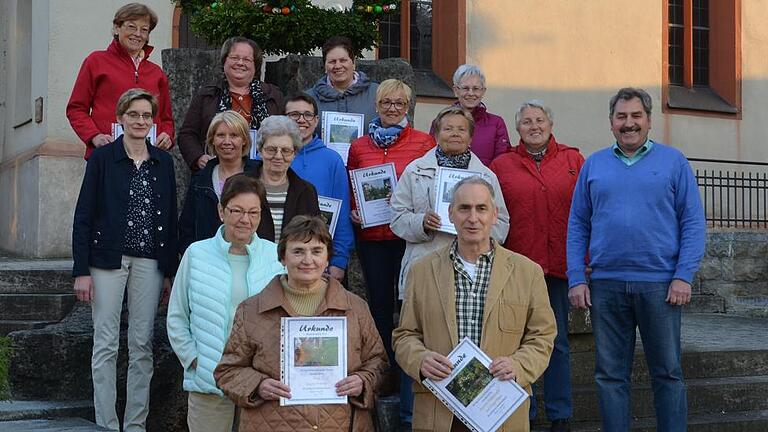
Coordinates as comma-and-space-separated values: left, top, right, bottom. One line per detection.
91, 255, 163, 432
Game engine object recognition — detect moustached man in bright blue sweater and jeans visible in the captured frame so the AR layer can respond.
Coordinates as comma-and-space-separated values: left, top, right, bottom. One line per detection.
567, 88, 706, 432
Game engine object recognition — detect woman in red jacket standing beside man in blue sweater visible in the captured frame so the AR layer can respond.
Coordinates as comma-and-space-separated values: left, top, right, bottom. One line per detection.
490, 100, 584, 431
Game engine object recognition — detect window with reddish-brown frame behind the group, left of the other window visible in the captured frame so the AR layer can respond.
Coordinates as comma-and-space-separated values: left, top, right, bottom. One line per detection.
378, 0, 466, 98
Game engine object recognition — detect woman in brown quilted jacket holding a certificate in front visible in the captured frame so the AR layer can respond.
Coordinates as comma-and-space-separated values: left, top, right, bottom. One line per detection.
214, 216, 388, 432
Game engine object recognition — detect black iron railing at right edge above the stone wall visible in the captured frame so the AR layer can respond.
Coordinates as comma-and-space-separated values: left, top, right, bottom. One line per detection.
688, 158, 768, 228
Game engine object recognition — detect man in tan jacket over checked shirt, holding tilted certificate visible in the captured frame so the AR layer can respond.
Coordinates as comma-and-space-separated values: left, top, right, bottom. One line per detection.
392, 177, 557, 432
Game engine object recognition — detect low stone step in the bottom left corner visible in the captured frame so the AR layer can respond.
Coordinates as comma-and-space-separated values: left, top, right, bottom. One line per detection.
0, 400, 93, 422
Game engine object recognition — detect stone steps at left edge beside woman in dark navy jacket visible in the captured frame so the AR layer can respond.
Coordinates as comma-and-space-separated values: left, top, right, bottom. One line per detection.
0, 257, 76, 336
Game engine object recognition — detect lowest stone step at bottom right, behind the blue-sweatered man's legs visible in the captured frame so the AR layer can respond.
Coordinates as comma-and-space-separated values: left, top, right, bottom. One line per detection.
531, 410, 768, 432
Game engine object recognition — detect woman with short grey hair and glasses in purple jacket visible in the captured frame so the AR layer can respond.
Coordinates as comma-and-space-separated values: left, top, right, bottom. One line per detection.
429, 64, 509, 166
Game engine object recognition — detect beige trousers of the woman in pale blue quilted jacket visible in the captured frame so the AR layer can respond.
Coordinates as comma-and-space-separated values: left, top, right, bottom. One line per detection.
187, 392, 235, 432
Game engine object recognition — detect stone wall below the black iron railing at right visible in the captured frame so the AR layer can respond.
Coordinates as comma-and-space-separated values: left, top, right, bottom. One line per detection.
694, 230, 768, 317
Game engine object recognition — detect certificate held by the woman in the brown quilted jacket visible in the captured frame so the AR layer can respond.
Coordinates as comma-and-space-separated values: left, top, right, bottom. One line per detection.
280, 317, 347, 406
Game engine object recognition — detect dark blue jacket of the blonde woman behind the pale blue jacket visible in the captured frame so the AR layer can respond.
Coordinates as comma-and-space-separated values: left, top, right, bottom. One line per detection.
179, 157, 258, 255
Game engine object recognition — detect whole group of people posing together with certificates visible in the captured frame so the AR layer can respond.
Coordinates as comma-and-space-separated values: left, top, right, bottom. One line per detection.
67, 3, 705, 431
